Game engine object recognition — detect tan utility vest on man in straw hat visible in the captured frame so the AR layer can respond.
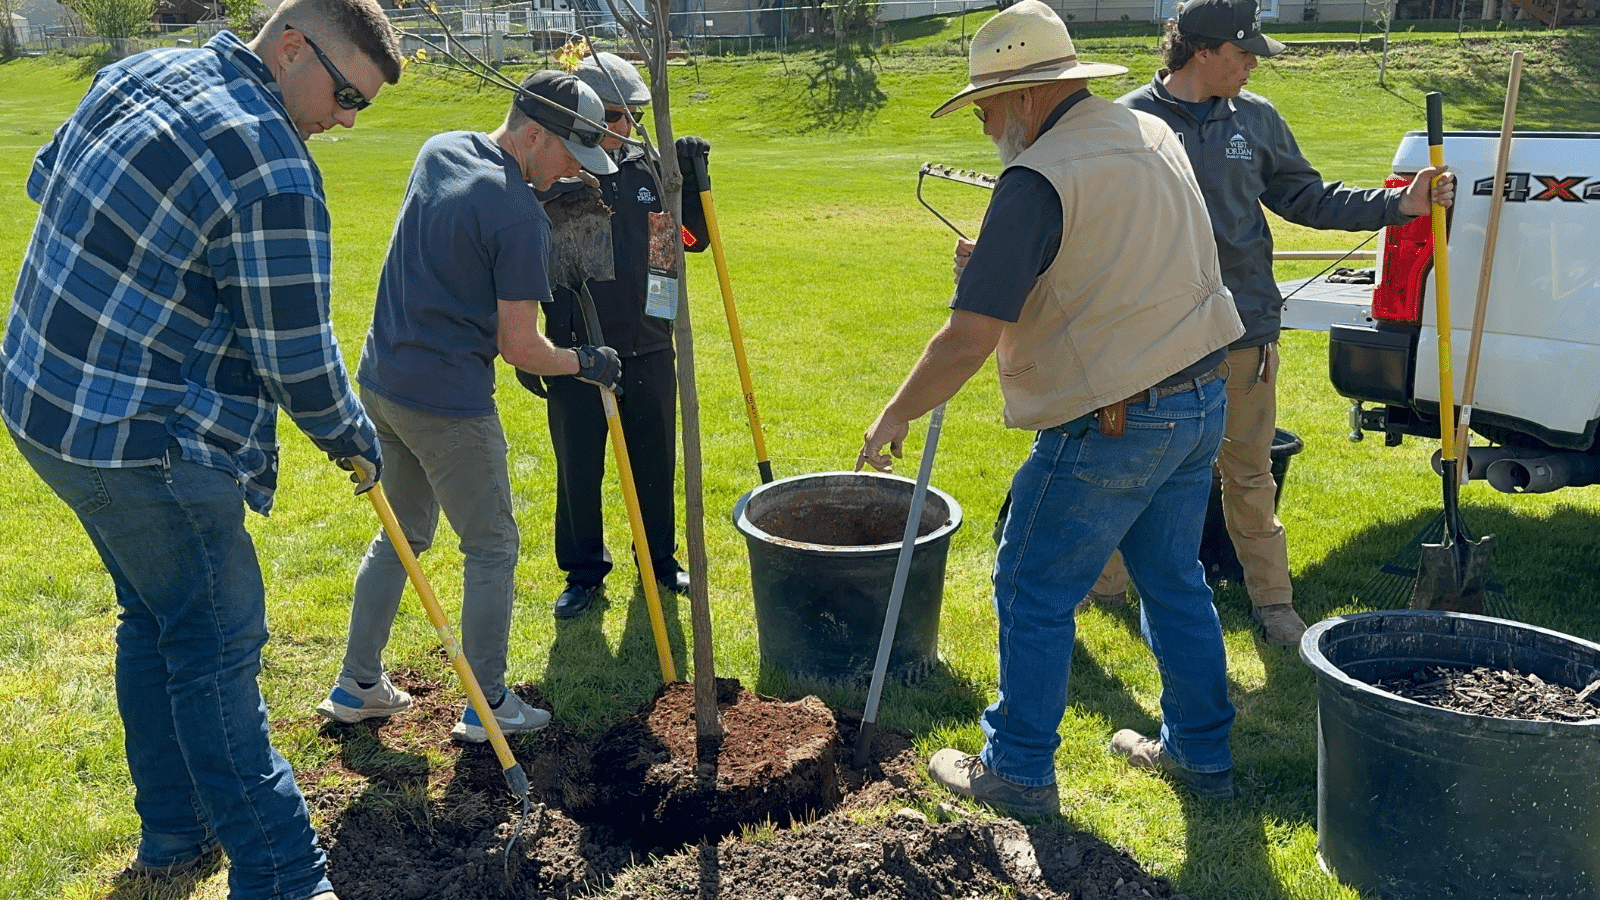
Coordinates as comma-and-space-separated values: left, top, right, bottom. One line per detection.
998, 96, 1245, 431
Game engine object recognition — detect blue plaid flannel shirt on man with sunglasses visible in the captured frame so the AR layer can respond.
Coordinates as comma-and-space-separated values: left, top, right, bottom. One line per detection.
0, 32, 376, 514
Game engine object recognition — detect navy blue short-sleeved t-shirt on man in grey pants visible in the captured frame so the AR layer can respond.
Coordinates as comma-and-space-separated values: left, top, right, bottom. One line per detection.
357, 131, 550, 418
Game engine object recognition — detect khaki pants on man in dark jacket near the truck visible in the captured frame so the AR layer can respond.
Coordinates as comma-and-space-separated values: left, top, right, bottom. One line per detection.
1093, 343, 1294, 607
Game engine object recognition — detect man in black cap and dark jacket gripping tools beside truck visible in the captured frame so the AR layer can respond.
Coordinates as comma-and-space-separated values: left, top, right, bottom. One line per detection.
1085, 0, 1456, 647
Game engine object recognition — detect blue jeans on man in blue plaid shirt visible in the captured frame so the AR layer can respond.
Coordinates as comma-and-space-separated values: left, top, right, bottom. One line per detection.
11, 434, 331, 900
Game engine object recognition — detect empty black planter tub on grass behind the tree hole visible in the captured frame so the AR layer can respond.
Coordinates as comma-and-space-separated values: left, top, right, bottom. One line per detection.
733, 472, 962, 684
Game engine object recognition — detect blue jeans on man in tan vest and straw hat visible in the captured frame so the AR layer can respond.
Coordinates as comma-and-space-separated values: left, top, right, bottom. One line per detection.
982, 380, 1234, 786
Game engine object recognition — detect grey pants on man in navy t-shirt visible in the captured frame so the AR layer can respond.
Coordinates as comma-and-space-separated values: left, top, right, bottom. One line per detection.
342, 388, 520, 703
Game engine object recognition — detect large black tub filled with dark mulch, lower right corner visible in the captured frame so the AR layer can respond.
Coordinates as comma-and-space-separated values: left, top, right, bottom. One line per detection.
1301, 610, 1600, 900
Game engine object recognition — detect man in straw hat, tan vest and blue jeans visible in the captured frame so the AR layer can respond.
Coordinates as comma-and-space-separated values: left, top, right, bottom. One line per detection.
858, 0, 1243, 815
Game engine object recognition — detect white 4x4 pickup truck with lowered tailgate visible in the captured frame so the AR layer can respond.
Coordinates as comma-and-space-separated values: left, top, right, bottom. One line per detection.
1282, 131, 1600, 493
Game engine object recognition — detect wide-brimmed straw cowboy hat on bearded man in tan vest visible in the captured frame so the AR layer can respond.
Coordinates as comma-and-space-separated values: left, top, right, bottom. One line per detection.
933, 0, 1128, 119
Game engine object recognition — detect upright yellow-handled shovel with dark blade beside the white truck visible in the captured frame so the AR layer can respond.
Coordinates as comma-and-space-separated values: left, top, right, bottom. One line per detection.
1411, 91, 1494, 613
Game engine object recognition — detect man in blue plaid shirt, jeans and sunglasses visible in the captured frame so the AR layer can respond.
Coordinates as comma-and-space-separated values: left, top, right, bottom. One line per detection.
0, 0, 400, 900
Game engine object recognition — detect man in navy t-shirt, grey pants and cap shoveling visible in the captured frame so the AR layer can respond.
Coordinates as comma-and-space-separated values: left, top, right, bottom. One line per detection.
317, 72, 621, 743
